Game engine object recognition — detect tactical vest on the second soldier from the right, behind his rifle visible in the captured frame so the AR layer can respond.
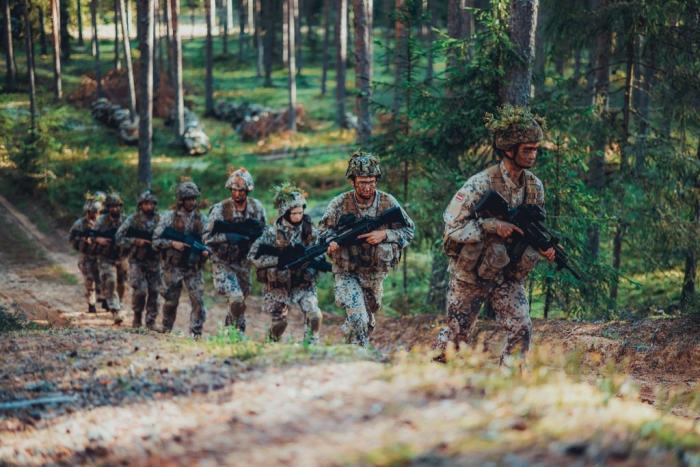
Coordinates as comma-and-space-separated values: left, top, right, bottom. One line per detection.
332, 191, 401, 274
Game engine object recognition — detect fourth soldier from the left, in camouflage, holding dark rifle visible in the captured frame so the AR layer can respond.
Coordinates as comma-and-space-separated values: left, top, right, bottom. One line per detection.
153, 180, 209, 338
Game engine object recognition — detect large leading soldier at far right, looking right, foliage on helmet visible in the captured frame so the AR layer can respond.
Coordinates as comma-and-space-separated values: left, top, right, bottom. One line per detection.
435, 106, 555, 363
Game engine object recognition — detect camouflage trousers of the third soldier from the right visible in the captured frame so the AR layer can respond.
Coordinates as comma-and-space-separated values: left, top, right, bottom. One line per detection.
263, 287, 323, 344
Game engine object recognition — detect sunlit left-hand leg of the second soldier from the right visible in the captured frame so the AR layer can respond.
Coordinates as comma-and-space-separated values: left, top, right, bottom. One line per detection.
335, 274, 369, 346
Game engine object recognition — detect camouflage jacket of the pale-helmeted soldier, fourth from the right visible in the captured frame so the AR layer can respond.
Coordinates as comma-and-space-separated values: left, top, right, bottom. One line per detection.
204, 198, 267, 267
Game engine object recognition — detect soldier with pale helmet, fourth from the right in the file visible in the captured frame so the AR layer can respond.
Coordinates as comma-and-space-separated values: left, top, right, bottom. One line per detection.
204, 169, 266, 333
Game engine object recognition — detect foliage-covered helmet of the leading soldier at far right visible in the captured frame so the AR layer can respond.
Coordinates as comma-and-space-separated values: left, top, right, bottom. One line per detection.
484, 104, 546, 151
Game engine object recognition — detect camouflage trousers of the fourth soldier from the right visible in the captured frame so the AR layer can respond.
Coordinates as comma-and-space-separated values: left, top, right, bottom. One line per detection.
212, 261, 250, 332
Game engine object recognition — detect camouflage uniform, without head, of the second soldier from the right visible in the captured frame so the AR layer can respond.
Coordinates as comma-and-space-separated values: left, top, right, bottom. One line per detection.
320, 190, 415, 346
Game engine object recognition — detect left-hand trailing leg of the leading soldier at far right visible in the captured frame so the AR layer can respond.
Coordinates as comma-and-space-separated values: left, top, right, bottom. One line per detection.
433, 277, 488, 360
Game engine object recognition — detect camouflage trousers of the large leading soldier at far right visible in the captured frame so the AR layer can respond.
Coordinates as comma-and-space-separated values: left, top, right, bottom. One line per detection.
434, 276, 532, 362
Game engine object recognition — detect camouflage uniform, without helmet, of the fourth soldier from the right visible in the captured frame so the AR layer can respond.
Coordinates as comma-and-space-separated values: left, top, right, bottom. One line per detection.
204, 197, 267, 332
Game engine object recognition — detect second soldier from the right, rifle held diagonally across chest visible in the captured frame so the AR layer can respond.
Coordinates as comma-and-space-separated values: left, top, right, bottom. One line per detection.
320, 152, 415, 346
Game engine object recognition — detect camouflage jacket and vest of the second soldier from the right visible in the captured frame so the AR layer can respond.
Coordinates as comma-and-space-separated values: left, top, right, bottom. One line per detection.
320, 190, 415, 274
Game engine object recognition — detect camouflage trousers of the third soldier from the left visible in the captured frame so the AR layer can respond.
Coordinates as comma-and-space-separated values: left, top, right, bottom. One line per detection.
129, 259, 163, 329
